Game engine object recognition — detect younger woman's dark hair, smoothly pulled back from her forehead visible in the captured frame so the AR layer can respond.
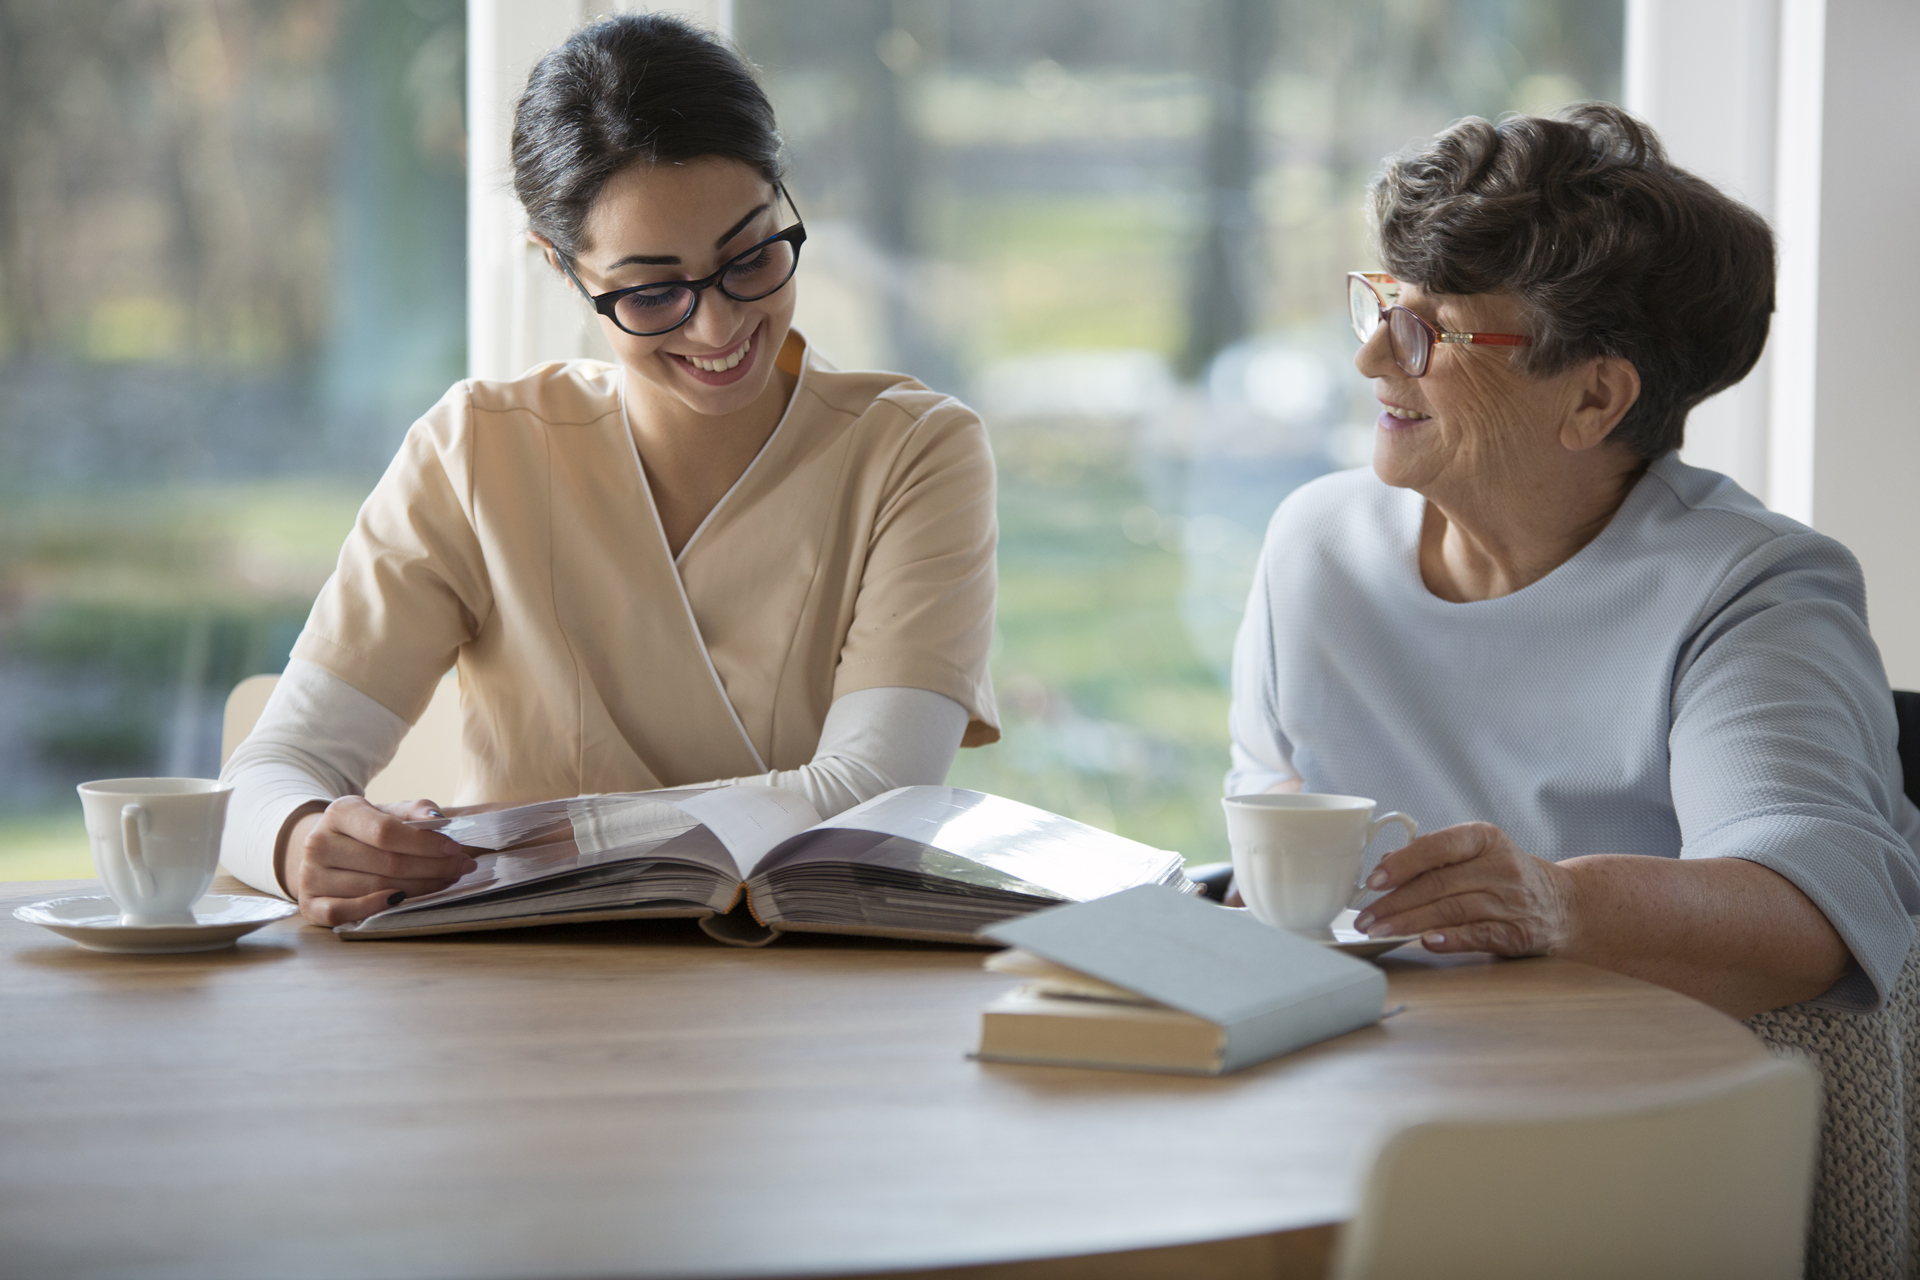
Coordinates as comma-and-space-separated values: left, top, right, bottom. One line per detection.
513, 13, 781, 257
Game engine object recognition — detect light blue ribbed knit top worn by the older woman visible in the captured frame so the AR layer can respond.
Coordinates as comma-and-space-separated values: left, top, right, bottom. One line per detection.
1227, 455, 1920, 1009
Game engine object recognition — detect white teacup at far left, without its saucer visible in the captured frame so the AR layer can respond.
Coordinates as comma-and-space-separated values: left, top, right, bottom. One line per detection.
79, 777, 232, 925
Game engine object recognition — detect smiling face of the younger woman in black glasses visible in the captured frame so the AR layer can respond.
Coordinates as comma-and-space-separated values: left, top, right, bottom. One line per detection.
574, 157, 795, 415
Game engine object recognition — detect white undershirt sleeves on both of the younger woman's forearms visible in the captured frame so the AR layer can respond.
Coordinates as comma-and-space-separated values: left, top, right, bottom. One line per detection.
221, 658, 968, 898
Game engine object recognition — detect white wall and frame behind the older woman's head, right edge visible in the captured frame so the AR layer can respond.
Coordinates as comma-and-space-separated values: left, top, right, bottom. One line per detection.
1626, 0, 1920, 689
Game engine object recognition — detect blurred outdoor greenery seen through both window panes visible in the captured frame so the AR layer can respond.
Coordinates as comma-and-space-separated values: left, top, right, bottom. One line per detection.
0, 0, 1624, 879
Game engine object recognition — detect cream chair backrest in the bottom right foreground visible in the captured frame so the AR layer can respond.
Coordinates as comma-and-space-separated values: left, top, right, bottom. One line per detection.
1332, 1057, 1820, 1280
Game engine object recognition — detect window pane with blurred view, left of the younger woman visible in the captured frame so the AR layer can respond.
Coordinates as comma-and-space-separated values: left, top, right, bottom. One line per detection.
0, 0, 467, 879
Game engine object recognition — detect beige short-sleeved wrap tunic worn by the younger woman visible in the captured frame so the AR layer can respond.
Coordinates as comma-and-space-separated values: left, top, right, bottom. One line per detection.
294, 334, 1000, 804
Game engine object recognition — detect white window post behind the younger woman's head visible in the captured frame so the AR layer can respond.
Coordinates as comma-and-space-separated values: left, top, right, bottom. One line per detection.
467, 0, 733, 378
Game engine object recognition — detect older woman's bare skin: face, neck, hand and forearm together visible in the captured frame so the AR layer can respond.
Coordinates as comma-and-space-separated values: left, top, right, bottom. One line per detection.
1328, 286, 1851, 1017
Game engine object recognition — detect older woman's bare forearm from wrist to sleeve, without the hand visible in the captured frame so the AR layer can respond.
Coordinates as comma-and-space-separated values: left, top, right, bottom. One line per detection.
1557, 856, 1853, 1017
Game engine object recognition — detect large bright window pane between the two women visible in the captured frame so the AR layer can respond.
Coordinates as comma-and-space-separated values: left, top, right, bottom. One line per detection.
733, 0, 1624, 860
